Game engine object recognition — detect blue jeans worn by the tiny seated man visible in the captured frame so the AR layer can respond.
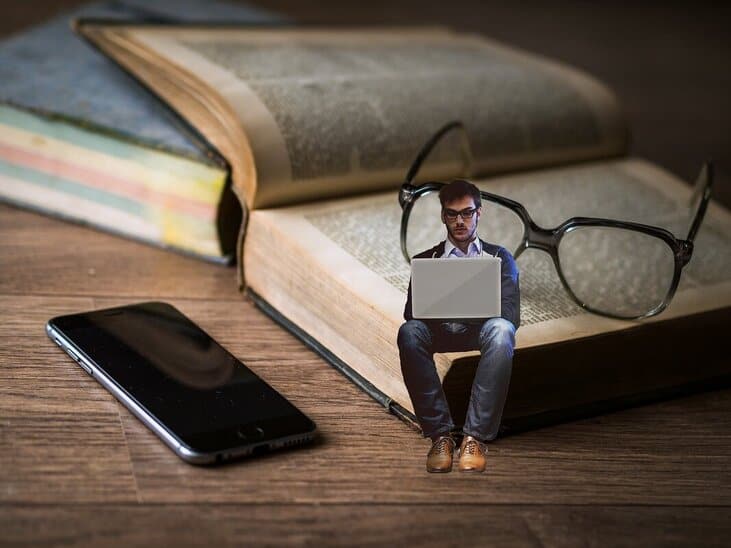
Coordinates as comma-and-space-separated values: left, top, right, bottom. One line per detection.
398, 318, 515, 441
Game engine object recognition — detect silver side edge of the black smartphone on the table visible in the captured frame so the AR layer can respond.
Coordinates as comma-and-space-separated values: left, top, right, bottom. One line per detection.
46, 320, 317, 464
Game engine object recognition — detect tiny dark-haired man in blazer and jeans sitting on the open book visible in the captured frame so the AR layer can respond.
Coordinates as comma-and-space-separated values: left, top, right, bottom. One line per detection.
398, 180, 520, 472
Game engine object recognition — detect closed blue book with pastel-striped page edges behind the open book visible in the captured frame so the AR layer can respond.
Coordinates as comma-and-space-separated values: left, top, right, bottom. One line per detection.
0, 0, 278, 261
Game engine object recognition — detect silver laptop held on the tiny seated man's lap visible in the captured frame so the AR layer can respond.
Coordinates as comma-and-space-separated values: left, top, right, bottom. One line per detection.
411, 255, 502, 320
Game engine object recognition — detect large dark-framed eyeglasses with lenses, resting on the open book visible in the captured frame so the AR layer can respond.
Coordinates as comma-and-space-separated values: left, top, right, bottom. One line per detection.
399, 122, 713, 319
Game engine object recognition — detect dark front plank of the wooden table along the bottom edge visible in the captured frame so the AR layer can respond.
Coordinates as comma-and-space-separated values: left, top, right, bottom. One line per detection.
5, 503, 728, 548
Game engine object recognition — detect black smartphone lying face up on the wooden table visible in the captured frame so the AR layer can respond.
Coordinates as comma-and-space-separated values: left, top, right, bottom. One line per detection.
46, 302, 317, 464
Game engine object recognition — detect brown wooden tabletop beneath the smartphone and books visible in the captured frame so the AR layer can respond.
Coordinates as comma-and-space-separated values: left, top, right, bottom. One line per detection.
0, 0, 731, 546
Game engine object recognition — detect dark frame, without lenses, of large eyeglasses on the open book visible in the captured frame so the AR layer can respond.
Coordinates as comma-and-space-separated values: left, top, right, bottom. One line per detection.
399, 121, 714, 320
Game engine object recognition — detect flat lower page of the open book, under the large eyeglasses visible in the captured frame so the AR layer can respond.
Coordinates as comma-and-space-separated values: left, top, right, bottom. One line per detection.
254, 156, 731, 347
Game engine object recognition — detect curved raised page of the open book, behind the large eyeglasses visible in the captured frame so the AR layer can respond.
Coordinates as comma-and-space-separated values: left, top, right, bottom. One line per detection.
83, 23, 626, 208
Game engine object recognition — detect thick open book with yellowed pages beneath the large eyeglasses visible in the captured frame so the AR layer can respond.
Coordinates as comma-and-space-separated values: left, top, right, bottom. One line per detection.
79, 23, 731, 427
